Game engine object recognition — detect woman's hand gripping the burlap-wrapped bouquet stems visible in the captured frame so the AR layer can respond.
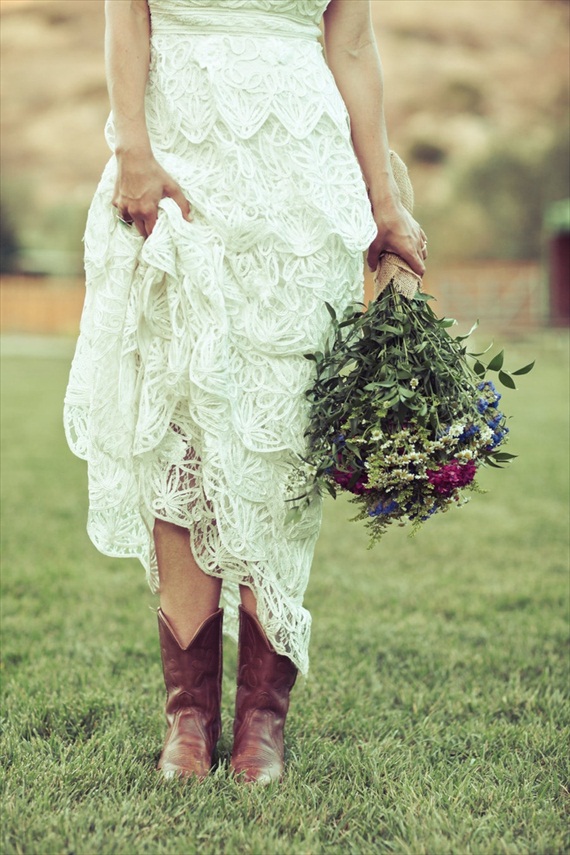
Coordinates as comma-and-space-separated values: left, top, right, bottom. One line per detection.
366, 200, 427, 276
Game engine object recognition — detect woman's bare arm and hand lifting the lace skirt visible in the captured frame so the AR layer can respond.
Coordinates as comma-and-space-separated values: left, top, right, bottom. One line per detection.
105, 0, 190, 237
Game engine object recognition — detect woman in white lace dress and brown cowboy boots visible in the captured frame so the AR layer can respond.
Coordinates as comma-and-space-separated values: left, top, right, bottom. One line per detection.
65, 0, 426, 783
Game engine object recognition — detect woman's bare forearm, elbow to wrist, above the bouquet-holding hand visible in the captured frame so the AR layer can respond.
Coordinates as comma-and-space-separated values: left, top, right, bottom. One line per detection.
327, 37, 399, 212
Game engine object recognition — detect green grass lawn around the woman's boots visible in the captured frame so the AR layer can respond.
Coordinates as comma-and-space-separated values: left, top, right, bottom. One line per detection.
2, 333, 570, 855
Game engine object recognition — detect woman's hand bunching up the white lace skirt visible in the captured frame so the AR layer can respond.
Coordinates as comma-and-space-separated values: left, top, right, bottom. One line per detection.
113, 153, 192, 238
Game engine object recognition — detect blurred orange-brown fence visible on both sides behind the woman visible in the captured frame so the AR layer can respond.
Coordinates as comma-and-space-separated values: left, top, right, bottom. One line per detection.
0, 261, 548, 335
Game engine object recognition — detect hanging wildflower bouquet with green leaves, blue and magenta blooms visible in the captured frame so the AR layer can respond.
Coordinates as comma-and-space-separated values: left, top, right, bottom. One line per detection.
290, 283, 534, 545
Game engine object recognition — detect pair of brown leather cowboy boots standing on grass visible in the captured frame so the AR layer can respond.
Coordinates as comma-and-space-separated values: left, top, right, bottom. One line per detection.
158, 606, 297, 784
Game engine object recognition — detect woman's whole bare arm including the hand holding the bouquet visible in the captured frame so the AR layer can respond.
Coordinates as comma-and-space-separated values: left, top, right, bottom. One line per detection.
324, 0, 427, 276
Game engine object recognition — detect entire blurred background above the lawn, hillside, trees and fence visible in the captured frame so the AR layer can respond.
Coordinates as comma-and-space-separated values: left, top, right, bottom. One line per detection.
0, 0, 570, 335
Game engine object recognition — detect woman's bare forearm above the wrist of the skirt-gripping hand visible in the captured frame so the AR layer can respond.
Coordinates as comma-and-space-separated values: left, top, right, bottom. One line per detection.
105, 0, 151, 154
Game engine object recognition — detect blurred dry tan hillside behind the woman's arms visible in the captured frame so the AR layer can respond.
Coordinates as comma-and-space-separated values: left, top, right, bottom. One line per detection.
0, 0, 569, 269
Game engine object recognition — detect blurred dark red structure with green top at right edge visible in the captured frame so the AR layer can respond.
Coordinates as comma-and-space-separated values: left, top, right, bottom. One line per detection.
545, 199, 570, 327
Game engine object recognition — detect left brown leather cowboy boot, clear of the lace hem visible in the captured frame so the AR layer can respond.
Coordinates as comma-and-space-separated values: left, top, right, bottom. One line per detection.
158, 609, 223, 778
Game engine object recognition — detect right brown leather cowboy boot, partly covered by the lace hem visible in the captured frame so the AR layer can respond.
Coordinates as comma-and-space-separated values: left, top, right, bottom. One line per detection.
231, 606, 297, 784
